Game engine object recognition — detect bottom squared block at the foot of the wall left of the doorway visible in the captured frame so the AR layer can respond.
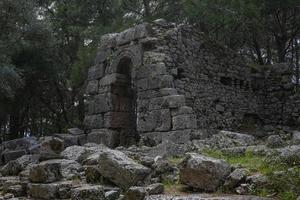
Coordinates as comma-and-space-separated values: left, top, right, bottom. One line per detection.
87, 129, 120, 148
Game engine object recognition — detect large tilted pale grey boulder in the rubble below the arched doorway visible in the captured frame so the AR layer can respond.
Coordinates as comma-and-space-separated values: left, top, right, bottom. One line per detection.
99, 150, 151, 189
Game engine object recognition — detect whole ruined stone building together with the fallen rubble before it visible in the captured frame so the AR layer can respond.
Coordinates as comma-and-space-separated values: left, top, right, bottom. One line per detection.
0, 20, 300, 200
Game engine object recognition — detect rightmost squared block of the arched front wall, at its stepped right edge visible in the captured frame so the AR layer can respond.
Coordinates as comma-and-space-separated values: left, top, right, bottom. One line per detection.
172, 114, 197, 130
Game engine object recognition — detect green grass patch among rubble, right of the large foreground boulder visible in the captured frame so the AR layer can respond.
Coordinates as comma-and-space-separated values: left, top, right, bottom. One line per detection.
202, 149, 300, 200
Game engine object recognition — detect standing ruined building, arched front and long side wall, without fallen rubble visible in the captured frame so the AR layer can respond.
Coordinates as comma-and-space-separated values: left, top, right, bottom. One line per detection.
85, 21, 299, 146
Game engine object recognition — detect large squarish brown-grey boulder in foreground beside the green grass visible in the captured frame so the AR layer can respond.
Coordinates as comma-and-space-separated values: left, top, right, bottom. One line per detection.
179, 153, 231, 191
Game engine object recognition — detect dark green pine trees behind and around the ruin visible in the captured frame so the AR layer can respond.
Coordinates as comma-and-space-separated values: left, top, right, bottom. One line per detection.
0, 0, 300, 140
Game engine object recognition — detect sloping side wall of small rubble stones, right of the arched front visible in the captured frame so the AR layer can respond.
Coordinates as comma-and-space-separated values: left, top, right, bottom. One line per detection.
166, 26, 262, 130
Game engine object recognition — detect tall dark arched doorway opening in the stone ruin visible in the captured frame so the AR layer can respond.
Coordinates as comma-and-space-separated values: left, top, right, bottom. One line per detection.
111, 57, 138, 145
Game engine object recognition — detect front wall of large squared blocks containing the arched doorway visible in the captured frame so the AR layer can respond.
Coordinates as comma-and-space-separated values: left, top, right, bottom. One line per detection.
85, 24, 196, 146
